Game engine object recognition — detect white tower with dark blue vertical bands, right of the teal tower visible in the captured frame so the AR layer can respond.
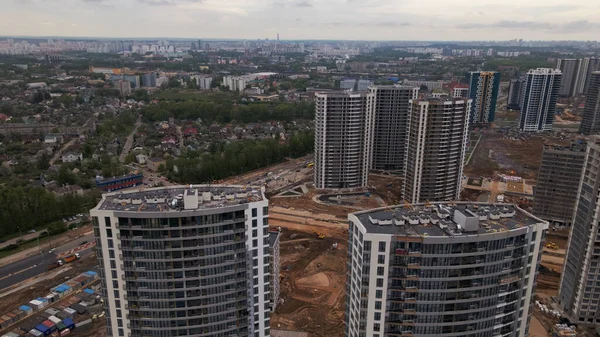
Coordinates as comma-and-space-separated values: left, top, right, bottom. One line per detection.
519, 68, 562, 132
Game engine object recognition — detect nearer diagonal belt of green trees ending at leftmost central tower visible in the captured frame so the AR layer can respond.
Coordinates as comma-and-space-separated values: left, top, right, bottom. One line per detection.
167, 131, 314, 184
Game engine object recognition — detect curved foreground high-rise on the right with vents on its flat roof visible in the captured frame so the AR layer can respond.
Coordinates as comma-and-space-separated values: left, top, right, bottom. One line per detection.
345, 202, 548, 337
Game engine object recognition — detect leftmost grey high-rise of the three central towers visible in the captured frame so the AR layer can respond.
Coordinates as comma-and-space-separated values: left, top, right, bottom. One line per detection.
314, 92, 372, 188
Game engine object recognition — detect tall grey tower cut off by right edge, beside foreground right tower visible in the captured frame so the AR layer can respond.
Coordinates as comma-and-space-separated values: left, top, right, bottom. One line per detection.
558, 144, 600, 325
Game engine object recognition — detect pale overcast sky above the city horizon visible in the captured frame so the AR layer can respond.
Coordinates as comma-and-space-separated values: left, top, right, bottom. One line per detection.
0, 0, 600, 40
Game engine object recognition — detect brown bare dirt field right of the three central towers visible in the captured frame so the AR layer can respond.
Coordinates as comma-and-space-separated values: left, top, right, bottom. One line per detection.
465, 130, 544, 179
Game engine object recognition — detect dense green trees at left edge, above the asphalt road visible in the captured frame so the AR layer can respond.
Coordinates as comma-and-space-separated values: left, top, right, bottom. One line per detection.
0, 187, 98, 237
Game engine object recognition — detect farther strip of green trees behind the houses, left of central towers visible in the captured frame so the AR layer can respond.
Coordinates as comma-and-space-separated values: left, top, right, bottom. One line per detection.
142, 100, 315, 124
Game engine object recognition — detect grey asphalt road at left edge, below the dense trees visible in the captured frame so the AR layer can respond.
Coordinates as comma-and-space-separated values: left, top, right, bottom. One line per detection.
0, 234, 94, 291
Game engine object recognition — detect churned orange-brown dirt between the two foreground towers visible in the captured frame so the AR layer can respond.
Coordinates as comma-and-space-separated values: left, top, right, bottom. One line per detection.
271, 226, 348, 336
